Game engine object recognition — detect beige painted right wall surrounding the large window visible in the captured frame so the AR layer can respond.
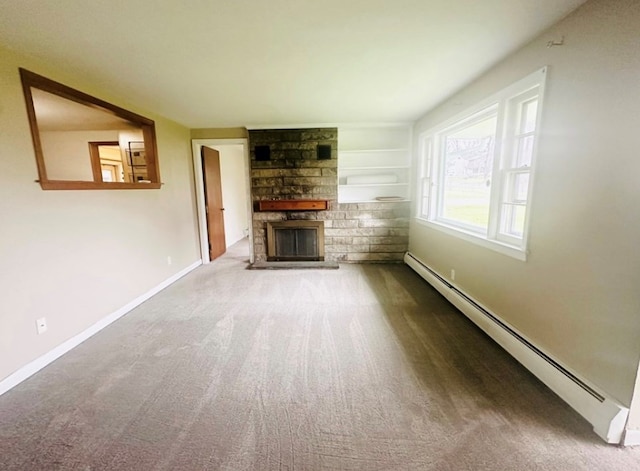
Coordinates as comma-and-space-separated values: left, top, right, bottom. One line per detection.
410, 0, 640, 405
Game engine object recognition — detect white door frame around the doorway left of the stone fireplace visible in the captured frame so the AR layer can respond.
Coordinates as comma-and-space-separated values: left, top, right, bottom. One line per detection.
191, 138, 254, 265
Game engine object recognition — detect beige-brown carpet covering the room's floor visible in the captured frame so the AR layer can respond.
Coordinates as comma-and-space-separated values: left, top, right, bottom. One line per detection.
0, 243, 640, 471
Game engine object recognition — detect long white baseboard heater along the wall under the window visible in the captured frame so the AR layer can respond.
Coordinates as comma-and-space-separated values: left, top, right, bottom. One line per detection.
404, 252, 629, 444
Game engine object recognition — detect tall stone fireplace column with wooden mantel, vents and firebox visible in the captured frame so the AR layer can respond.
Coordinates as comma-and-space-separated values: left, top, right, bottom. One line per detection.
249, 128, 338, 262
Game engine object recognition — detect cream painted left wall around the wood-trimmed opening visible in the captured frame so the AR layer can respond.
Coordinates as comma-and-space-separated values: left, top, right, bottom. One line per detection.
0, 43, 200, 381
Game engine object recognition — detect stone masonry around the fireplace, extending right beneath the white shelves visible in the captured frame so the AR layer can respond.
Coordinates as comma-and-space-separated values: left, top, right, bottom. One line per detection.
249, 128, 409, 262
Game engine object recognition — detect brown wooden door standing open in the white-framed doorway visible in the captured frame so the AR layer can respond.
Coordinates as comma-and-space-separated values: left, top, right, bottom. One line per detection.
202, 146, 227, 260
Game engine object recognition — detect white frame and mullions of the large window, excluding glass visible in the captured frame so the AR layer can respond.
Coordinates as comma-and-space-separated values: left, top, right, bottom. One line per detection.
415, 67, 547, 260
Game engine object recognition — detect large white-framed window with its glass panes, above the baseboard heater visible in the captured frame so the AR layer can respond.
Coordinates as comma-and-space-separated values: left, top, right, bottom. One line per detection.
417, 68, 546, 259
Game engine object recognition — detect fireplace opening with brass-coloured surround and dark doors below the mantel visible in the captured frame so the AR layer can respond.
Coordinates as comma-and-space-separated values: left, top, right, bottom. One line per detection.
267, 221, 324, 262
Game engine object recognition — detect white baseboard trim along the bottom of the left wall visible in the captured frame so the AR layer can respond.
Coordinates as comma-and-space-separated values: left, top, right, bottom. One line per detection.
0, 260, 202, 396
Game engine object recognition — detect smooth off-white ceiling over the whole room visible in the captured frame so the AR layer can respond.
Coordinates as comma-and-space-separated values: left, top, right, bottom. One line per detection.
0, 0, 585, 128
